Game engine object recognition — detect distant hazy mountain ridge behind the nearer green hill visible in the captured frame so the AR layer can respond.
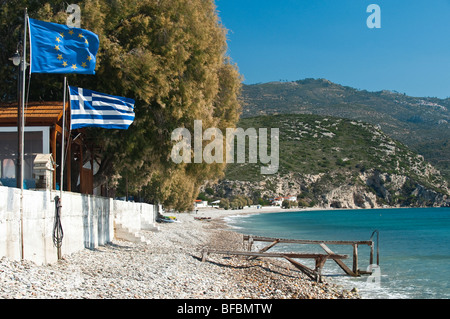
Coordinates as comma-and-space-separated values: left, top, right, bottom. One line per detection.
242, 79, 450, 180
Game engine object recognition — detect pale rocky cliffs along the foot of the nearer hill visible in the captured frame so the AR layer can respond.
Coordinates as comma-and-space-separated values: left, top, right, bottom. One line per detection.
209, 171, 450, 208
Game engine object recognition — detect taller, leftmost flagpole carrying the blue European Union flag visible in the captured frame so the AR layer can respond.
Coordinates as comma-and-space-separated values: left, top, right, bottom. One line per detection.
20, 8, 28, 261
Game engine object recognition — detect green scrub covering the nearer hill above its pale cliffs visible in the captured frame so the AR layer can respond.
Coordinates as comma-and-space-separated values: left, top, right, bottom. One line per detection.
225, 114, 447, 208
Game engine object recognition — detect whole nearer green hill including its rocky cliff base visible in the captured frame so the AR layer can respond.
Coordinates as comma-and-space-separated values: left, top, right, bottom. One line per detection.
206, 114, 448, 208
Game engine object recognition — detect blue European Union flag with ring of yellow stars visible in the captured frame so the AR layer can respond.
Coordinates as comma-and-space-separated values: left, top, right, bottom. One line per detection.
29, 18, 100, 74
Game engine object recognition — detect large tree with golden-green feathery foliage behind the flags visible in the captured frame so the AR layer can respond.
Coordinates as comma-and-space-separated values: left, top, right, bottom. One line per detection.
0, 0, 241, 210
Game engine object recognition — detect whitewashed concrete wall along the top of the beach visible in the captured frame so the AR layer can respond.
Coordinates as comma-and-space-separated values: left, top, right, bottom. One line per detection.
0, 186, 157, 264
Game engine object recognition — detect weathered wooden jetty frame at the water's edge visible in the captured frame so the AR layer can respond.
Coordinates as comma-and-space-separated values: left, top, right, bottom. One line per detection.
202, 230, 379, 282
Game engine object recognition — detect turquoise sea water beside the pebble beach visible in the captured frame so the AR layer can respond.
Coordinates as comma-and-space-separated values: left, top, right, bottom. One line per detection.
228, 208, 450, 299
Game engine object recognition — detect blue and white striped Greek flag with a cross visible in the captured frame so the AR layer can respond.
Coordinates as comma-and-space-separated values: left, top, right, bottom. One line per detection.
69, 86, 135, 130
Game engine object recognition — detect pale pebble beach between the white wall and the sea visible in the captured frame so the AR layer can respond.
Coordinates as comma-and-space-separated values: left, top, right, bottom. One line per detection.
0, 208, 359, 299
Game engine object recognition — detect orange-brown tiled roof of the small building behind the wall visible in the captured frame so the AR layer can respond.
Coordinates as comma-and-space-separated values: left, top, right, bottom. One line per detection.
0, 101, 69, 126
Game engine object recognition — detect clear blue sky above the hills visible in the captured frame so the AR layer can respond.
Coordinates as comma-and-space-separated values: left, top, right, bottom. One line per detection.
216, 0, 450, 98
